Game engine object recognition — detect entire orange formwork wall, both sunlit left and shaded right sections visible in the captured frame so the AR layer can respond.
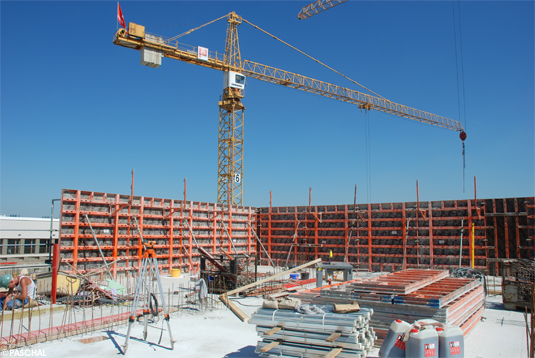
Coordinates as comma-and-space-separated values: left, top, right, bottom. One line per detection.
60, 189, 535, 276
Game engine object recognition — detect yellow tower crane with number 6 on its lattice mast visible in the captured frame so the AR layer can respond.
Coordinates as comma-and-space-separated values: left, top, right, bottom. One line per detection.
113, 12, 466, 205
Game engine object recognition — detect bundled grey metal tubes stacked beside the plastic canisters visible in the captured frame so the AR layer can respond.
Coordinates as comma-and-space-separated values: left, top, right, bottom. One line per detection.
249, 305, 376, 358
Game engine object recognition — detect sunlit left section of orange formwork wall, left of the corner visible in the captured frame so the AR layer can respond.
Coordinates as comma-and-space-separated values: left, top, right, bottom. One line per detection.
60, 189, 256, 277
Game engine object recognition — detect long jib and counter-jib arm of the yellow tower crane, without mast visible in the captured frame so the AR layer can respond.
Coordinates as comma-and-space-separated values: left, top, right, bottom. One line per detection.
113, 29, 464, 132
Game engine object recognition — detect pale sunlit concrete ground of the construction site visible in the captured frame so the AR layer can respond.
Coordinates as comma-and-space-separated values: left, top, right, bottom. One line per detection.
3, 274, 529, 358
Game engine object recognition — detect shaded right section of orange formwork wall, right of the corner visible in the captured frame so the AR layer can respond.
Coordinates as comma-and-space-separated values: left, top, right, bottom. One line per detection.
257, 197, 535, 274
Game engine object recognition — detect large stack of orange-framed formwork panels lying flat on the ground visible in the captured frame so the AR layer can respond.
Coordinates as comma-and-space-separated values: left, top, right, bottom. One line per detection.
294, 270, 485, 343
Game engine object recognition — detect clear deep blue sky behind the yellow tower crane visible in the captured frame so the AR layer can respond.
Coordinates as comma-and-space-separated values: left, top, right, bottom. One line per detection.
0, 0, 535, 217
